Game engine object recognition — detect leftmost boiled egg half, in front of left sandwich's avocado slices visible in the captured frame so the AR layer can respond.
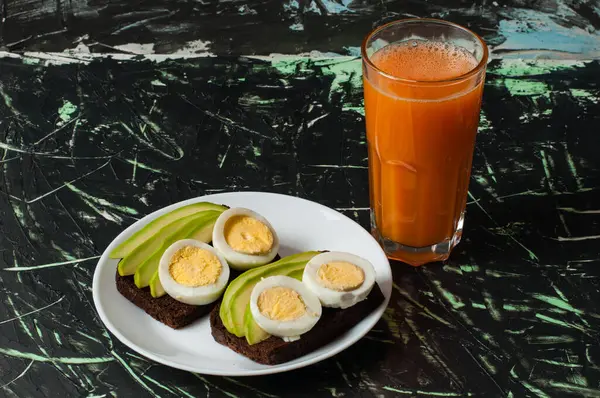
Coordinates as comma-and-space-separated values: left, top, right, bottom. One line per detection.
158, 239, 230, 305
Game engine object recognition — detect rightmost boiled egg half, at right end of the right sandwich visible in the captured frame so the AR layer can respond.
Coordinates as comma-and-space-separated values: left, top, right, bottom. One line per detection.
302, 251, 375, 309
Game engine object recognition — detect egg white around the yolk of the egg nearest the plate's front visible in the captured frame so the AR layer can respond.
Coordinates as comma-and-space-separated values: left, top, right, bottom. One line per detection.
250, 275, 323, 341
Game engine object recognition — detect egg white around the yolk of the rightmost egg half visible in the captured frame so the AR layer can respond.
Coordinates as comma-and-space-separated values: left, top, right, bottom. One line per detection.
302, 251, 375, 309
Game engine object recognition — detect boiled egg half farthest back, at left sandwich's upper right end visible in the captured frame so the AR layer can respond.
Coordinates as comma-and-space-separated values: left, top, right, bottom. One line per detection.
212, 207, 279, 271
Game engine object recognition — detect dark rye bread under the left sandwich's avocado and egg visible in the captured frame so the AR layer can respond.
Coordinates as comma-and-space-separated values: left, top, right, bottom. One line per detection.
116, 272, 216, 329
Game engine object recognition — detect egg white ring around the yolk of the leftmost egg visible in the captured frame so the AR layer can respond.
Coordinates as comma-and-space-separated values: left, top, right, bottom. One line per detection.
158, 239, 230, 305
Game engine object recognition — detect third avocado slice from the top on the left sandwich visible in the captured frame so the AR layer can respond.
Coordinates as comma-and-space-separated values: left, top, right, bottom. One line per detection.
133, 210, 221, 289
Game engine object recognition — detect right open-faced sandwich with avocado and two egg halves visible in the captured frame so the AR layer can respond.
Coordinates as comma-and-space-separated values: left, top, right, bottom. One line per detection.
210, 251, 384, 365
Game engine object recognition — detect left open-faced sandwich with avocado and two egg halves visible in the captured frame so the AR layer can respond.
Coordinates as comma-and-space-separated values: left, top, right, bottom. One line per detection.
109, 202, 279, 329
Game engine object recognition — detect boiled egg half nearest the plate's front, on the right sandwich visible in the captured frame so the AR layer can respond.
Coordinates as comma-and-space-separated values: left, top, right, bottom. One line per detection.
250, 275, 322, 341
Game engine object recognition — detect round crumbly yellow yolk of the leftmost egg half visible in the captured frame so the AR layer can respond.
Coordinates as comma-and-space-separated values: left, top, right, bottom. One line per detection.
169, 246, 222, 287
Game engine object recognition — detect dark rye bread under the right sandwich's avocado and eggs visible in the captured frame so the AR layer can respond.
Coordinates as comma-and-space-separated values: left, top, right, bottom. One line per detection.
210, 284, 385, 365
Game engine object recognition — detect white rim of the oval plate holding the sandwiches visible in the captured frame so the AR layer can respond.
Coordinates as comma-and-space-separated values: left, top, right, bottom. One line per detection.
92, 191, 393, 377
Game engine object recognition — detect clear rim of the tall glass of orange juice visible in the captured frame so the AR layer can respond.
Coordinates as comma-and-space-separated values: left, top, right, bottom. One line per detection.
360, 18, 489, 85
